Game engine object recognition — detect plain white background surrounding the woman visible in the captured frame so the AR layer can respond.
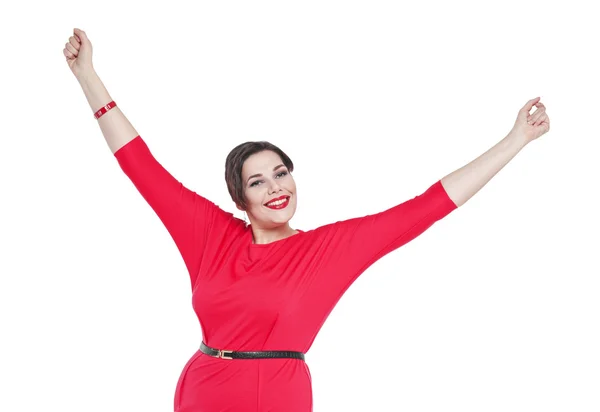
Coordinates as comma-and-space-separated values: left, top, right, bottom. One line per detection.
0, 0, 600, 412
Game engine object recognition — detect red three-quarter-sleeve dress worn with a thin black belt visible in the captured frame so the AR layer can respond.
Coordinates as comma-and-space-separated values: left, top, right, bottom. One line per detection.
115, 136, 457, 412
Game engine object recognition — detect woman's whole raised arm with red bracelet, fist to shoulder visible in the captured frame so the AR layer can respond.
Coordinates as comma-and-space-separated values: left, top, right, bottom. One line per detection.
63, 29, 243, 288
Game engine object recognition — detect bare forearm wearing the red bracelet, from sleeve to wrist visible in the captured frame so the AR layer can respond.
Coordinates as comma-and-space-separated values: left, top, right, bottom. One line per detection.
77, 70, 138, 154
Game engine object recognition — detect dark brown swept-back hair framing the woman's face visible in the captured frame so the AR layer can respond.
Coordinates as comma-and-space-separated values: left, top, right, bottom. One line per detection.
225, 141, 294, 210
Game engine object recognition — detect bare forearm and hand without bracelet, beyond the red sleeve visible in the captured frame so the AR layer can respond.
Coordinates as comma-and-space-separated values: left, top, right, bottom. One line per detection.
441, 97, 550, 207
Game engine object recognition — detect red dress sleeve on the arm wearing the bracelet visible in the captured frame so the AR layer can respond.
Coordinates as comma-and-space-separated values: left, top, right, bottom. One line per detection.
114, 136, 235, 288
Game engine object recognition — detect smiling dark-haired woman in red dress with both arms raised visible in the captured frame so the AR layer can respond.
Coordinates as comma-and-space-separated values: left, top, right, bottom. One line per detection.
63, 29, 550, 412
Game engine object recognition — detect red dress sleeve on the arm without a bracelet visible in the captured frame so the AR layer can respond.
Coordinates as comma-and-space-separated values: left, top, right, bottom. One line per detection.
319, 181, 457, 300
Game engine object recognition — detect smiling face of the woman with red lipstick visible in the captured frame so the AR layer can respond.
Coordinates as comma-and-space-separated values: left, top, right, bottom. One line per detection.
242, 150, 296, 229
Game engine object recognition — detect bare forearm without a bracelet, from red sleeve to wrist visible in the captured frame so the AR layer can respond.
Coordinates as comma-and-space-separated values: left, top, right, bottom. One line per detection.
442, 134, 527, 207
